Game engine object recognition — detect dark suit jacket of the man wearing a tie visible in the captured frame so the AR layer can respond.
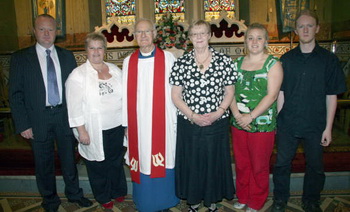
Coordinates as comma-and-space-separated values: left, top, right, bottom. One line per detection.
9, 45, 77, 140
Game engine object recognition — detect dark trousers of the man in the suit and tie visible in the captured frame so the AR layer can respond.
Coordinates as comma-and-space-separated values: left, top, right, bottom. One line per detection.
31, 108, 83, 209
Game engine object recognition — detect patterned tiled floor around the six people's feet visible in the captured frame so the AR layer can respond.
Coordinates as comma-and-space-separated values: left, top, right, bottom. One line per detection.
0, 190, 350, 212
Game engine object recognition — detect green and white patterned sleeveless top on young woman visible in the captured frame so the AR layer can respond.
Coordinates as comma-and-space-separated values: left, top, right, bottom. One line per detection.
231, 55, 279, 132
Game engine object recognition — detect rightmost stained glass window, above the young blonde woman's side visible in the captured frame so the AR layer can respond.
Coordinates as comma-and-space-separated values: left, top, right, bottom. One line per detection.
204, 0, 236, 21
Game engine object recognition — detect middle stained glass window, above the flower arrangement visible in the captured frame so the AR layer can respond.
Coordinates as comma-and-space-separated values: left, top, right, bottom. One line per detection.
154, 0, 185, 22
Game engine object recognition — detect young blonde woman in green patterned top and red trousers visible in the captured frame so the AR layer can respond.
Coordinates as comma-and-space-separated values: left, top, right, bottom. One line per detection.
230, 23, 283, 211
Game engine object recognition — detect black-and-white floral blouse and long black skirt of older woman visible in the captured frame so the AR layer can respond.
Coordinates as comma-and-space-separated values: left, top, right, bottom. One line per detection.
170, 47, 237, 207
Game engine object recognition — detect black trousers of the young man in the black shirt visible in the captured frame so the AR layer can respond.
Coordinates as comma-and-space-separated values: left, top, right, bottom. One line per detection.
273, 128, 325, 202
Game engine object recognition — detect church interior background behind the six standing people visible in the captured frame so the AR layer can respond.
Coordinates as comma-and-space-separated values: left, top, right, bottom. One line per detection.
0, 0, 350, 211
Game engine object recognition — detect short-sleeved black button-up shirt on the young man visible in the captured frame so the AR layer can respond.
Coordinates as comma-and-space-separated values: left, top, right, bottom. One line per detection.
278, 44, 346, 136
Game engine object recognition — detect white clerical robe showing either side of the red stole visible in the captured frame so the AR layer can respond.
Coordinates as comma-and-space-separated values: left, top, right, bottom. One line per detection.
122, 51, 177, 175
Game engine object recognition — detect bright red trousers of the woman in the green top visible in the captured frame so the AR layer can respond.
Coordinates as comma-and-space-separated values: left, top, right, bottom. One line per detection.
231, 127, 275, 210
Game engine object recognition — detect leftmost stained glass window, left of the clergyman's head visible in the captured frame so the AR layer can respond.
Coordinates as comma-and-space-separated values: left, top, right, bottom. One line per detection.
105, 0, 135, 23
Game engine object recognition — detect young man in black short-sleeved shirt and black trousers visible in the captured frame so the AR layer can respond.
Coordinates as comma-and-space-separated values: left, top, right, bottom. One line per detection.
272, 10, 346, 212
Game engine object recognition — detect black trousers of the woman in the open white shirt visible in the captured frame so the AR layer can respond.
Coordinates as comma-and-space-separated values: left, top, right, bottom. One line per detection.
85, 126, 127, 204
